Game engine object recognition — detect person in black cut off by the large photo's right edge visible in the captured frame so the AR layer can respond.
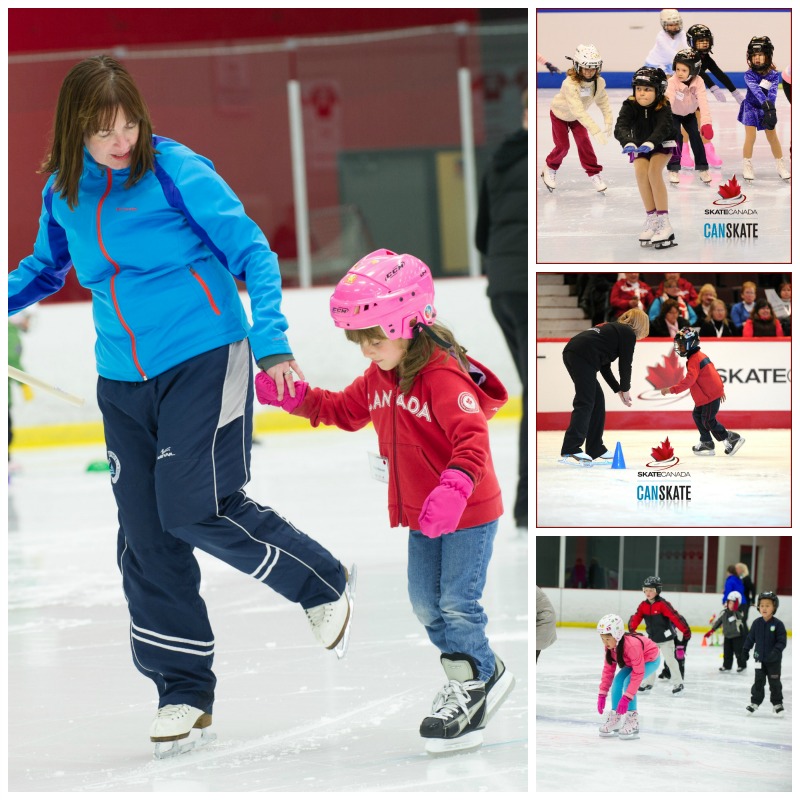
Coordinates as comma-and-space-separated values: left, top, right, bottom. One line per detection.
475, 91, 528, 528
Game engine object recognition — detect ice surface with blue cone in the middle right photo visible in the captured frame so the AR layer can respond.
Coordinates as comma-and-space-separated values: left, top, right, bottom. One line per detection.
536, 428, 791, 528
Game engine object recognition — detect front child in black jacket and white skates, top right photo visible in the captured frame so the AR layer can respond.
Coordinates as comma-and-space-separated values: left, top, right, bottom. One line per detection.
614, 67, 676, 249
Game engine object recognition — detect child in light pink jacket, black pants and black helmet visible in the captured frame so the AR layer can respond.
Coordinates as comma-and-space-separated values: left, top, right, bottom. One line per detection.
665, 49, 714, 184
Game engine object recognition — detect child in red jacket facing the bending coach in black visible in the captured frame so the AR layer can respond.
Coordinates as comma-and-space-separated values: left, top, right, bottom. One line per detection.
661, 328, 744, 456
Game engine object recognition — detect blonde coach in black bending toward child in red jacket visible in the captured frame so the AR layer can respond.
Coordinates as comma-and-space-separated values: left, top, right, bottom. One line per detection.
561, 308, 650, 467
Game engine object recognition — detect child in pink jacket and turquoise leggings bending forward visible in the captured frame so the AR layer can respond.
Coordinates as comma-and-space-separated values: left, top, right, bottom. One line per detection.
597, 614, 661, 739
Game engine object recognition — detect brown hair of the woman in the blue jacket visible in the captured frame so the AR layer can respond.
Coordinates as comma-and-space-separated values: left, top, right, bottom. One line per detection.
39, 56, 155, 209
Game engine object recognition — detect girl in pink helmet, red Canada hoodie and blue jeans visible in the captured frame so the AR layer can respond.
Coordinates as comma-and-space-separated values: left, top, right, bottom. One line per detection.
256, 250, 514, 753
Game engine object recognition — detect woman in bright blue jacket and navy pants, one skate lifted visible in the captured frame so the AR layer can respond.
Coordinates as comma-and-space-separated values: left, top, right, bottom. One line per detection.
9, 56, 350, 750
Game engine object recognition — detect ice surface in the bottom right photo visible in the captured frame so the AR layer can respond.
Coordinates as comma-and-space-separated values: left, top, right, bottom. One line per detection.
536, 632, 792, 797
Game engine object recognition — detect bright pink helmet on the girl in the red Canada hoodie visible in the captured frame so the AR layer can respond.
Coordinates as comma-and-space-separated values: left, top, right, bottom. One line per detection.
330, 250, 436, 339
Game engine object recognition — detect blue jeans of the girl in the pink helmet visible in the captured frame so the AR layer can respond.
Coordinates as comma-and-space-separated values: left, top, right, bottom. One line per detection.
408, 520, 497, 682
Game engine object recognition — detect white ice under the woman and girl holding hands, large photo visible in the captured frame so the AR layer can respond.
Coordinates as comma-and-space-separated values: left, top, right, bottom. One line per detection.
8, 420, 528, 792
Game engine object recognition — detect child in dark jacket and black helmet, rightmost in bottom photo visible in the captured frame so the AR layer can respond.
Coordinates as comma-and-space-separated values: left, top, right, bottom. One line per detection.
743, 592, 786, 716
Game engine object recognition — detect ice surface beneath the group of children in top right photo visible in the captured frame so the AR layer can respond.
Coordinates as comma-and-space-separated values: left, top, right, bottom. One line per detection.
535, 89, 791, 266
